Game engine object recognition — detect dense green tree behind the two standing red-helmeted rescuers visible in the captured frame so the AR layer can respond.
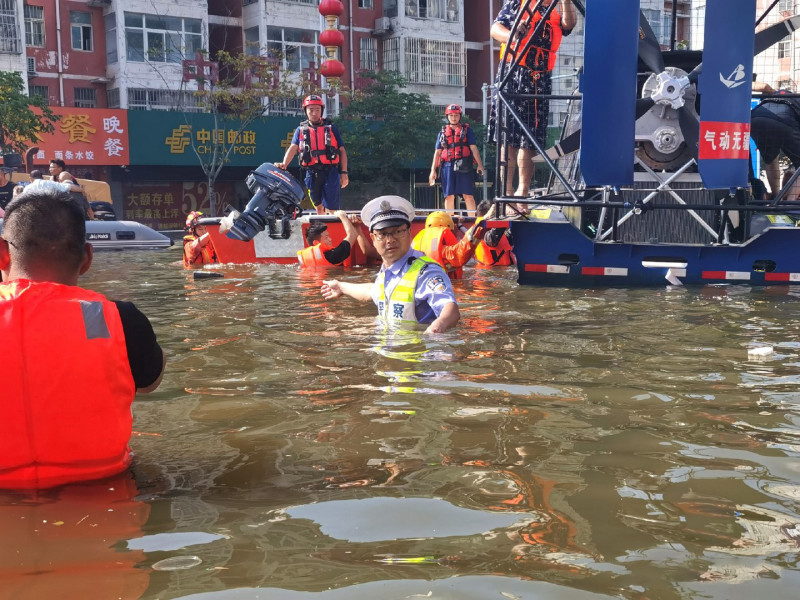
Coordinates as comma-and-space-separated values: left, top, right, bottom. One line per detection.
334, 71, 443, 182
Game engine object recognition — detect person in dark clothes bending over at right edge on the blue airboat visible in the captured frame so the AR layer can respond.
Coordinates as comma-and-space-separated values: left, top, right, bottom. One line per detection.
750, 90, 800, 199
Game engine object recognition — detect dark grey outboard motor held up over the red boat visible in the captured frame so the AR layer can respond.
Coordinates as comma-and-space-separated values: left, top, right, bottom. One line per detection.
220, 163, 305, 242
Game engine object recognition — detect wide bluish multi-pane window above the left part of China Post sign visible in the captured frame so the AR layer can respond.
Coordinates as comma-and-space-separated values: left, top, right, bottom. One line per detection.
125, 13, 203, 63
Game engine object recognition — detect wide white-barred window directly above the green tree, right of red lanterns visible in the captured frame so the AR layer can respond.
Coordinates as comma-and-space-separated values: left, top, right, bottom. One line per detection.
403, 38, 467, 87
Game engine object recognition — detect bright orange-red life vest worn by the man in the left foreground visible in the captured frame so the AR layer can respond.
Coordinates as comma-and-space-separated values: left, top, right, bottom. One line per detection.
0, 279, 136, 489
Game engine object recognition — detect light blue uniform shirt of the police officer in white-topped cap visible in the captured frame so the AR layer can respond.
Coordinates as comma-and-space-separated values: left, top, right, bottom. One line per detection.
372, 249, 456, 323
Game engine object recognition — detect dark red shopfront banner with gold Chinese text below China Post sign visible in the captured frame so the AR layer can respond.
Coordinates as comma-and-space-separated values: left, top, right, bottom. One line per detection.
122, 181, 234, 230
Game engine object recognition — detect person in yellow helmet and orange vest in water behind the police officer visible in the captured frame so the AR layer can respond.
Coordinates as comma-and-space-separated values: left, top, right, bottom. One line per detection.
411, 210, 484, 279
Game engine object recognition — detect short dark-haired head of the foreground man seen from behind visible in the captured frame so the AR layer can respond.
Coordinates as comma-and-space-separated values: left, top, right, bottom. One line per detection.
0, 188, 86, 269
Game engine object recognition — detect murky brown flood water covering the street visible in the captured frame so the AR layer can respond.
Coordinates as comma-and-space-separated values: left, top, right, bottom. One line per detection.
0, 248, 800, 600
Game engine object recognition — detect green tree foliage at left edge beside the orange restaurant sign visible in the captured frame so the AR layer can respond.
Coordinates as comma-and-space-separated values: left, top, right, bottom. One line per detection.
0, 71, 60, 154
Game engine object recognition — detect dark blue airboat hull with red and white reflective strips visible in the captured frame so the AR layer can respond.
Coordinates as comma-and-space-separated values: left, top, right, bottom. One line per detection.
510, 220, 800, 287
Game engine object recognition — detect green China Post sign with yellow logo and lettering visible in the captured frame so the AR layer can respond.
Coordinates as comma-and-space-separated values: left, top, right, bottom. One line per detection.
128, 111, 298, 167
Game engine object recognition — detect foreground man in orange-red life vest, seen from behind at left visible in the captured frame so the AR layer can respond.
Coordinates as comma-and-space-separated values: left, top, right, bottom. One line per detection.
0, 189, 165, 489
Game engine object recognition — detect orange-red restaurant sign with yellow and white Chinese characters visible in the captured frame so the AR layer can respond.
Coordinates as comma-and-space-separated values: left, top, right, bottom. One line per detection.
33, 106, 130, 165
